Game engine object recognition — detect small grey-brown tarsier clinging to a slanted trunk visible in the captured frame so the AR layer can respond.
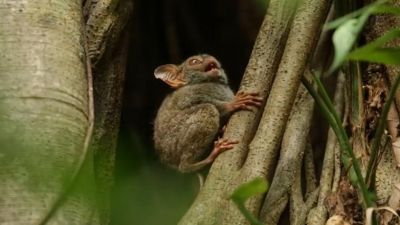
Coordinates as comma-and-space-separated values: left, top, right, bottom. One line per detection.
154, 55, 262, 172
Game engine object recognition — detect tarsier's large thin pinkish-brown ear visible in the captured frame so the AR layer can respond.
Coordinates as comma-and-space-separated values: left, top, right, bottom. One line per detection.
154, 64, 186, 88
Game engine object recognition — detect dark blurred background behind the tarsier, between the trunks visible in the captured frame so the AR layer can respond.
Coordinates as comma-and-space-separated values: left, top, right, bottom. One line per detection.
112, 0, 265, 225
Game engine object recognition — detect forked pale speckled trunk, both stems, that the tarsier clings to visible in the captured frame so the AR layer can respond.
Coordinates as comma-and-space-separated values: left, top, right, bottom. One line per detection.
180, 1, 330, 224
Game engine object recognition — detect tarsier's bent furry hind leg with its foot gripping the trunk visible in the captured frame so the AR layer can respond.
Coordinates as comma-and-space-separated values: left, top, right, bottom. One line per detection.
179, 104, 236, 172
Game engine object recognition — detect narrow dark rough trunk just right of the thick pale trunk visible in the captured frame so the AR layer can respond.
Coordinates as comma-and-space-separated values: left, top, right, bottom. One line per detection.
85, 1, 132, 224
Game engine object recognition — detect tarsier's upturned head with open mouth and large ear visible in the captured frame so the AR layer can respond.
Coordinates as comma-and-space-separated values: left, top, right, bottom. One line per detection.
154, 54, 228, 88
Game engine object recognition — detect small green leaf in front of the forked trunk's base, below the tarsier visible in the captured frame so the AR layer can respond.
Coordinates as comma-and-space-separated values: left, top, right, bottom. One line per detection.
231, 178, 268, 203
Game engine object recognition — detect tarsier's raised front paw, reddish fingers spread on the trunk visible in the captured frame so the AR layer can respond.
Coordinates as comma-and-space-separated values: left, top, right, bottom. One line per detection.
228, 91, 263, 112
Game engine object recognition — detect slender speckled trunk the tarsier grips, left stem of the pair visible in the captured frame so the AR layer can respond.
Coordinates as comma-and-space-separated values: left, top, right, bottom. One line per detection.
180, 0, 294, 225
